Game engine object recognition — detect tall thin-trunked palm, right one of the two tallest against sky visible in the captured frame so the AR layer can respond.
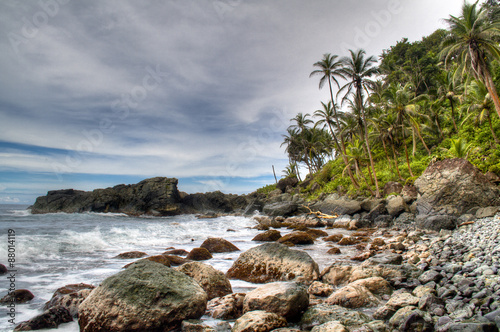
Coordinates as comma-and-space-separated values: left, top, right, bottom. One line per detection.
339, 49, 380, 197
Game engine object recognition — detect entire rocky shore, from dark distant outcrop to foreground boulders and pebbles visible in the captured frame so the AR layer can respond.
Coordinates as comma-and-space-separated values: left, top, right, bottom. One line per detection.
2, 159, 500, 332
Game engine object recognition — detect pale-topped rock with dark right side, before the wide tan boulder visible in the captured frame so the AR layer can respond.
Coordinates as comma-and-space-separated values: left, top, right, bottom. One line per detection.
243, 282, 309, 321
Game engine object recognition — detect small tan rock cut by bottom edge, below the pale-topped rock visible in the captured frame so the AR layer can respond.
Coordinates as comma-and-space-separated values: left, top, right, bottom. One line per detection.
232, 310, 287, 332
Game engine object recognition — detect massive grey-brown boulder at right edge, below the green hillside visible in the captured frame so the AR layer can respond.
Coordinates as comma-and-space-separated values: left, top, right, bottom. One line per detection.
415, 158, 500, 216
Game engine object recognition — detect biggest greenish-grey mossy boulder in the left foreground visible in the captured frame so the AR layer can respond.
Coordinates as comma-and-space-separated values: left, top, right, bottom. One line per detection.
78, 260, 207, 332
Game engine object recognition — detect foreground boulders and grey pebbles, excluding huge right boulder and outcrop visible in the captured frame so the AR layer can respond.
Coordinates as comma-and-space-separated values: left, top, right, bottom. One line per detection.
15, 214, 500, 332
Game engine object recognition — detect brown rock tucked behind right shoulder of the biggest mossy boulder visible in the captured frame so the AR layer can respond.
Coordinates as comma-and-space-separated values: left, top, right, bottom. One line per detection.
176, 262, 233, 300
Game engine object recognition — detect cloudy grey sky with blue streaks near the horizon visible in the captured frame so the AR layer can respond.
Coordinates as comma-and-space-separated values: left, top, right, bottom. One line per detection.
0, 0, 462, 204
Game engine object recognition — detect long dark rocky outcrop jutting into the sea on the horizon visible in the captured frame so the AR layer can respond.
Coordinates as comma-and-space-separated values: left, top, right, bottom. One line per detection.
31, 177, 248, 216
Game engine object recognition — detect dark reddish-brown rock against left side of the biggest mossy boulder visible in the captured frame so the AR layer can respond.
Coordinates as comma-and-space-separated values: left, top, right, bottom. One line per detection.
43, 283, 95, 317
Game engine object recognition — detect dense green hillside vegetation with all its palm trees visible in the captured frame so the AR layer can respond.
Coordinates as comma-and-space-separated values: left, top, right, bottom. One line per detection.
283, 1, 500, 196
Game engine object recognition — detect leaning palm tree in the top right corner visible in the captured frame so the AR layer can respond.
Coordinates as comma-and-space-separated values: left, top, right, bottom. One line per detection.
441, 1, 500, 117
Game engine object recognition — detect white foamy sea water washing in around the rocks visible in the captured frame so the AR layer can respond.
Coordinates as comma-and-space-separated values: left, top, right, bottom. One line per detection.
0, 205, 349, 332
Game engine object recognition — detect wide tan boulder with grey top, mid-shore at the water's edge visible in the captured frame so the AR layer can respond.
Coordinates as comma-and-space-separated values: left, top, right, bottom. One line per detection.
227, 243, 319, 285
